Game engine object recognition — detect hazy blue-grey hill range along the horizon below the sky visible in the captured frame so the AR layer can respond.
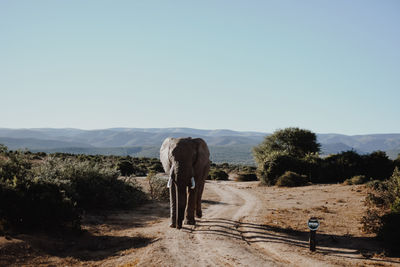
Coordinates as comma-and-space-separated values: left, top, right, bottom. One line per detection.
0, 128, 400, 164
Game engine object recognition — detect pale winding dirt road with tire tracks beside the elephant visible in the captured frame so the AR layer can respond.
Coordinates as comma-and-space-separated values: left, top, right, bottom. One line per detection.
139, 182, 282, 266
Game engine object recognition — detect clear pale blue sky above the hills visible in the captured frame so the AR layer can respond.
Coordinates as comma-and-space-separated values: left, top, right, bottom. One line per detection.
0, 0, 400, 134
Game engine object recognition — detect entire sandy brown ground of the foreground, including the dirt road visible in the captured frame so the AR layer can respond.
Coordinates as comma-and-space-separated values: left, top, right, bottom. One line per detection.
0, 181, 400, 266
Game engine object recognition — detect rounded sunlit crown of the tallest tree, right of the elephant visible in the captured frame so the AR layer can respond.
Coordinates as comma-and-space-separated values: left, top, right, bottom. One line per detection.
253, 127, 321, 164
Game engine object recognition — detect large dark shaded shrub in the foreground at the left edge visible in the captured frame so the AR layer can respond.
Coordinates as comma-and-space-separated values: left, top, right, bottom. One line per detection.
0, 153, 80, 229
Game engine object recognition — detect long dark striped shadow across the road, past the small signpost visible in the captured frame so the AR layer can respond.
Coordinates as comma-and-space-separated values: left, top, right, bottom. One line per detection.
185, 218, 400, 264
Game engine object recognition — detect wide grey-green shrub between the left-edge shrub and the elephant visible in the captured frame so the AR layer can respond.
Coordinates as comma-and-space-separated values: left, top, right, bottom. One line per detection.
36, 159, 146, 211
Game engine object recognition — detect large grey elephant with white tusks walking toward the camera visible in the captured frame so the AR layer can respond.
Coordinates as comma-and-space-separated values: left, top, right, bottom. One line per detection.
160, 137, 210, 229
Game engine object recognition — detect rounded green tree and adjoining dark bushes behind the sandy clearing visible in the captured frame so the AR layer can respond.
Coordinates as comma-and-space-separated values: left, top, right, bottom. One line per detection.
253, 128, 399, 185
